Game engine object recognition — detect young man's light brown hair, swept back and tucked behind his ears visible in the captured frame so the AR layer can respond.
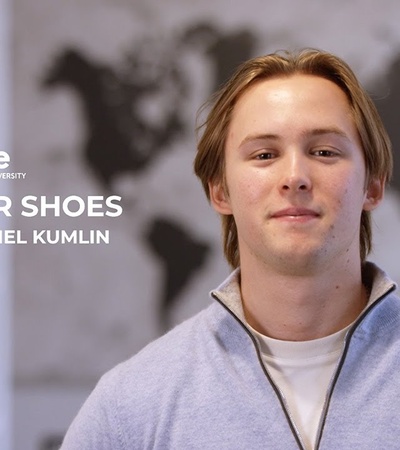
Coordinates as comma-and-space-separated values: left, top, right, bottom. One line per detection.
195, 50, 392, 267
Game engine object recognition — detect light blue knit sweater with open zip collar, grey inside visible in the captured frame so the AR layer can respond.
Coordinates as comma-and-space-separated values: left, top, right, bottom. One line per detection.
61, 263, 400, 450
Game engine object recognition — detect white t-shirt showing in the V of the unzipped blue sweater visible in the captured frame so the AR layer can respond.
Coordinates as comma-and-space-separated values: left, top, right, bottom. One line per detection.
250, 325, 350, 450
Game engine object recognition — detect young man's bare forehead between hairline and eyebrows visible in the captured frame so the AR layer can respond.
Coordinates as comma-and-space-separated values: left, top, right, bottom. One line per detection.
227, 75, 358, 142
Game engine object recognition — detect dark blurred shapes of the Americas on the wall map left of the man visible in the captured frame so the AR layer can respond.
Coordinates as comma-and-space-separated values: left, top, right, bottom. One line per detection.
40, 23, 257, 331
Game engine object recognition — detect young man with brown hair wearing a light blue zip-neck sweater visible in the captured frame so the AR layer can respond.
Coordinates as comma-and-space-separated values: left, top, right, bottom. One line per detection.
62, 50, 400, 450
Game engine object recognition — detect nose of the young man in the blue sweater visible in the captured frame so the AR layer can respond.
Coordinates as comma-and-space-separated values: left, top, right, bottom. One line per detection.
281, 153, 312, 192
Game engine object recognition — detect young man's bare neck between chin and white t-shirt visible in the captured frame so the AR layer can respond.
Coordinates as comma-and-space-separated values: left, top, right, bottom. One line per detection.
241, 256, 367, 341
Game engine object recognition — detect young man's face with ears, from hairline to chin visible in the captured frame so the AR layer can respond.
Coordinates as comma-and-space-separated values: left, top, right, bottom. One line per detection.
210, 75, 383, 273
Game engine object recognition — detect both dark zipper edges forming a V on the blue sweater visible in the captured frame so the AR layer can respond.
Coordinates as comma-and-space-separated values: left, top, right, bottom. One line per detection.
211, 284, 396, 450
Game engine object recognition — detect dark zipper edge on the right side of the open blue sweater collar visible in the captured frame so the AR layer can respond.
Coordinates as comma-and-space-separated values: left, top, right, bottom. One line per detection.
314, 284, 396, 450
